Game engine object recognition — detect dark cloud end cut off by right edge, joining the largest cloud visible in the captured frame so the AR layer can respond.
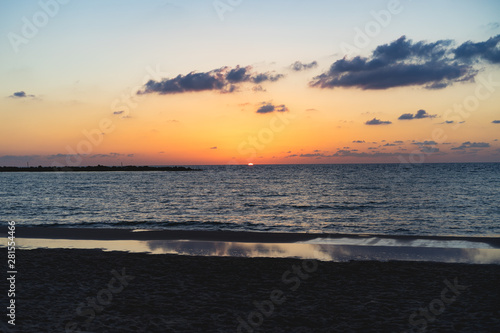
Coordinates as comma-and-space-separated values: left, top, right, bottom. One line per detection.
454, 35, 500, 64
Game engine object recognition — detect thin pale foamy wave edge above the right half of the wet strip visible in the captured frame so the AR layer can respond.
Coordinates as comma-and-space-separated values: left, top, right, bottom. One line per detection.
299, 237, 495, 249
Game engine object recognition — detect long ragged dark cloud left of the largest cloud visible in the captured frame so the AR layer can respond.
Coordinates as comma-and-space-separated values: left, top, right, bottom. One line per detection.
137, 66, 284, 95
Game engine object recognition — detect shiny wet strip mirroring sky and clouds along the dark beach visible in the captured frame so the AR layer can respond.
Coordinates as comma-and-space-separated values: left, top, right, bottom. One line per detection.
0, 238, 500, 264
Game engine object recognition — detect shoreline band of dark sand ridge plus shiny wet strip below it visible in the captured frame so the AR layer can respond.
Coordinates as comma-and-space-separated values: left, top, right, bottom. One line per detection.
0, 227, 500, 265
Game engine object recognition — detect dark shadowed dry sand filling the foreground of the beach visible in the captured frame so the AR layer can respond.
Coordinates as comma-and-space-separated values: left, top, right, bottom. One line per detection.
0, 249, 500, 333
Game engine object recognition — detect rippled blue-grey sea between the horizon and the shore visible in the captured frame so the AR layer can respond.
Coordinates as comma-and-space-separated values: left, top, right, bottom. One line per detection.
0, 163, 500, 235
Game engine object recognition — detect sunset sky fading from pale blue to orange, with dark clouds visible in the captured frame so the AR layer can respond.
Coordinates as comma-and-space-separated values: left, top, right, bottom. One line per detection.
0, 0, 500, 166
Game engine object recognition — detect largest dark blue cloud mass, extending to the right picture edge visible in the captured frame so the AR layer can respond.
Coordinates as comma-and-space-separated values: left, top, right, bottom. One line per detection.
310, 35, 500, 89
